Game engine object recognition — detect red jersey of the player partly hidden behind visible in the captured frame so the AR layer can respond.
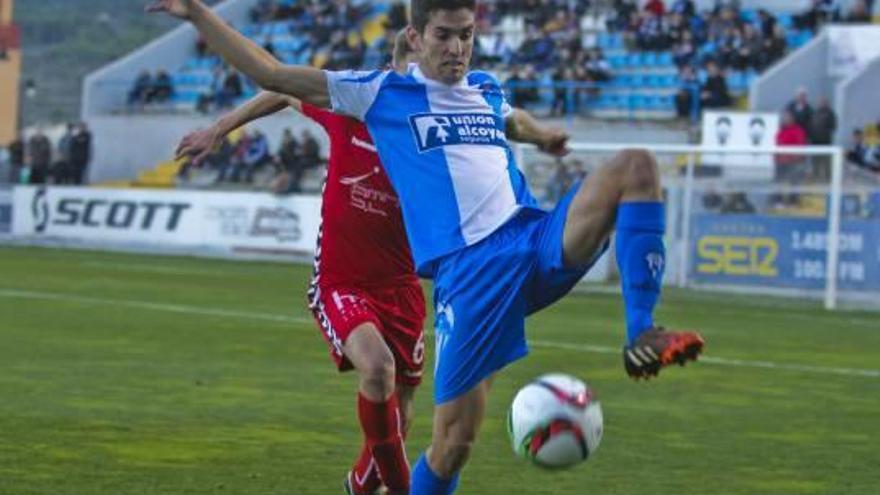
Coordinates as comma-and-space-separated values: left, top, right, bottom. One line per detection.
302, 103, 417, 286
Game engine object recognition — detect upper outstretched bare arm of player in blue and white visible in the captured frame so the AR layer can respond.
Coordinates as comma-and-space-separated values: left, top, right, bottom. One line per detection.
147, 0, 330, 108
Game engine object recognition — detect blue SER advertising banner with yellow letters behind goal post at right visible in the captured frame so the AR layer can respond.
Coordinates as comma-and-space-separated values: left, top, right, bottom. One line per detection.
690, 214, 880, 291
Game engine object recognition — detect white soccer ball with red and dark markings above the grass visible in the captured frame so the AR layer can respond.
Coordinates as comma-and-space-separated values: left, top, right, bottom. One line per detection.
507, 374, 602, 468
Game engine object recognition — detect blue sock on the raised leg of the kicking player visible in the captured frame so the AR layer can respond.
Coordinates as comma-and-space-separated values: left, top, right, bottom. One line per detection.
615, 201, 666, 345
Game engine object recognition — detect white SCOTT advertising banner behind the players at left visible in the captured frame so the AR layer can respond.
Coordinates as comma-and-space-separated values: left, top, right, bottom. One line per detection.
12, 186, 320, 255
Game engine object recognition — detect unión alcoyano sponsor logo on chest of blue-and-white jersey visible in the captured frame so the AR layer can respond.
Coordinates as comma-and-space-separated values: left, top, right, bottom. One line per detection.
409, 113, 507, 153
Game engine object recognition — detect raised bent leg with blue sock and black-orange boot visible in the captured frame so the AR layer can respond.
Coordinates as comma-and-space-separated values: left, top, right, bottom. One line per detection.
563, 150, 703, 378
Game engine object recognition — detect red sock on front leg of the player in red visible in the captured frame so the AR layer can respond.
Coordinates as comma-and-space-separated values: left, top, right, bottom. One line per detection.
358, 394, 409, 493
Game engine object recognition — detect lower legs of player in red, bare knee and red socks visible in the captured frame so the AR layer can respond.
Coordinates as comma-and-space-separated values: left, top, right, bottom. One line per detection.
343, 323, 411, 493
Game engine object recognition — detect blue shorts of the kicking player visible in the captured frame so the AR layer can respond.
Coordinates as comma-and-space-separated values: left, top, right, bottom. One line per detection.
434, 184, 607, 404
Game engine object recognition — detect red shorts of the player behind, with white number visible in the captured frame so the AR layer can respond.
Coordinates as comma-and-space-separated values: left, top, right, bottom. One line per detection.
309, 282, 425, 386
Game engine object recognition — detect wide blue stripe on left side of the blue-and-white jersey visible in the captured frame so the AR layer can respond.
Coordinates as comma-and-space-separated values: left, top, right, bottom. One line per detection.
365, 73, 465, 276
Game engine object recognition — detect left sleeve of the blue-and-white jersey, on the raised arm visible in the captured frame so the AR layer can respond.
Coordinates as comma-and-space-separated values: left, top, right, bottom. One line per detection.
326, 70, 388, 120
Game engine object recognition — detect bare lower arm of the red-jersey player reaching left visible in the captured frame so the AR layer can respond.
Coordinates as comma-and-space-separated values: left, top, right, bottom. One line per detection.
175, 91, 302, 165
